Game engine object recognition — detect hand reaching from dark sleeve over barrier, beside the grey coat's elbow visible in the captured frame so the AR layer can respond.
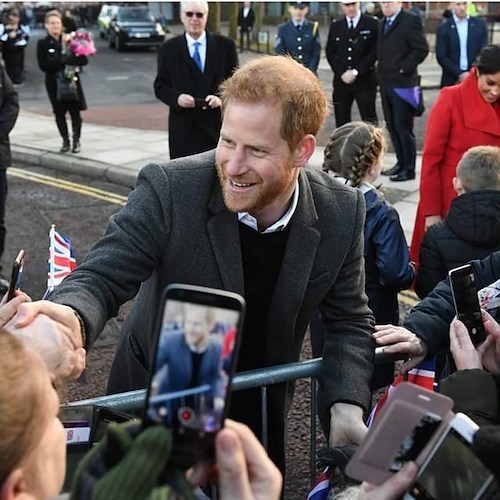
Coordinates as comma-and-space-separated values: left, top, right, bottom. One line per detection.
372, 325, 427, 373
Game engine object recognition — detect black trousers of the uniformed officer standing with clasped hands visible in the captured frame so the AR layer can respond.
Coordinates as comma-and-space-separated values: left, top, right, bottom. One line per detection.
333, 80, 378, 127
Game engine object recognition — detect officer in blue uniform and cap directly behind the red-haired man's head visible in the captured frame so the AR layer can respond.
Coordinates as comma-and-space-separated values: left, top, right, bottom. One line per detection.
274, 2, 321, 73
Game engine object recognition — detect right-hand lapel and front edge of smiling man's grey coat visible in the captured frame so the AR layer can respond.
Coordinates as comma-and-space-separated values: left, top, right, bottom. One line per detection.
266, 172, 321, 365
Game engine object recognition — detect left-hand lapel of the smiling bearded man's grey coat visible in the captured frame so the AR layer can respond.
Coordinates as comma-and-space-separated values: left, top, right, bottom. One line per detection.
207, 177, 244, 295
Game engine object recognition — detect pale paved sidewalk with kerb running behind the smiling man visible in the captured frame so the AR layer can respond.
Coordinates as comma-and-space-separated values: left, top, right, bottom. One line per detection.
10, 111, 421, 242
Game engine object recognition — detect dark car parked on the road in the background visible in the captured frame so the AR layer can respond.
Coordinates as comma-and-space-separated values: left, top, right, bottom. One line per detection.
108, 7, 165, 51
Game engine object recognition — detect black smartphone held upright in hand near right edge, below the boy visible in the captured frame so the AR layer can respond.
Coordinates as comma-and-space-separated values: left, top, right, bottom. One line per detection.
448, 264, 486, 346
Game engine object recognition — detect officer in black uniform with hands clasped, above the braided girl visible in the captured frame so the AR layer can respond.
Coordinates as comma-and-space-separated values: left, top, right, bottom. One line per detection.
326, 0, 378, 127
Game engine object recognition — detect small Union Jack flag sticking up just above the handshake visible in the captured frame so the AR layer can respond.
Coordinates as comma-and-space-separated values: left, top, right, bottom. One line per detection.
44, 225, 76, 298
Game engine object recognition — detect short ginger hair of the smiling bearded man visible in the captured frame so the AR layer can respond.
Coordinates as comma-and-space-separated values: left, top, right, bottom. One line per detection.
221, 56, 329, 150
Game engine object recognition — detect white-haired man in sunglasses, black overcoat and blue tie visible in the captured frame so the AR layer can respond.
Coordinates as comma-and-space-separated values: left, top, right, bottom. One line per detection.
154, 2, 238, 159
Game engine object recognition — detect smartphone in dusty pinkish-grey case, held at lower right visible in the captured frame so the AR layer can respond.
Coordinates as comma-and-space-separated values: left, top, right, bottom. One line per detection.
346, 382, 453, 485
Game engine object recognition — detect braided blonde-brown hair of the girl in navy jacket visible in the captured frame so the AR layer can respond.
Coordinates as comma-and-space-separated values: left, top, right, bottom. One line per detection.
322, 122, 387, 187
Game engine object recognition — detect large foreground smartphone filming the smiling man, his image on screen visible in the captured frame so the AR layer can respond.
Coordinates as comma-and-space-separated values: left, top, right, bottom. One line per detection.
144, 284, 245, 469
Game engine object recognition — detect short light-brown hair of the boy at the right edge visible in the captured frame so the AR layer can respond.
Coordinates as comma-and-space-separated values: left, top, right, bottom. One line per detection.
457, 146, 500, 191
